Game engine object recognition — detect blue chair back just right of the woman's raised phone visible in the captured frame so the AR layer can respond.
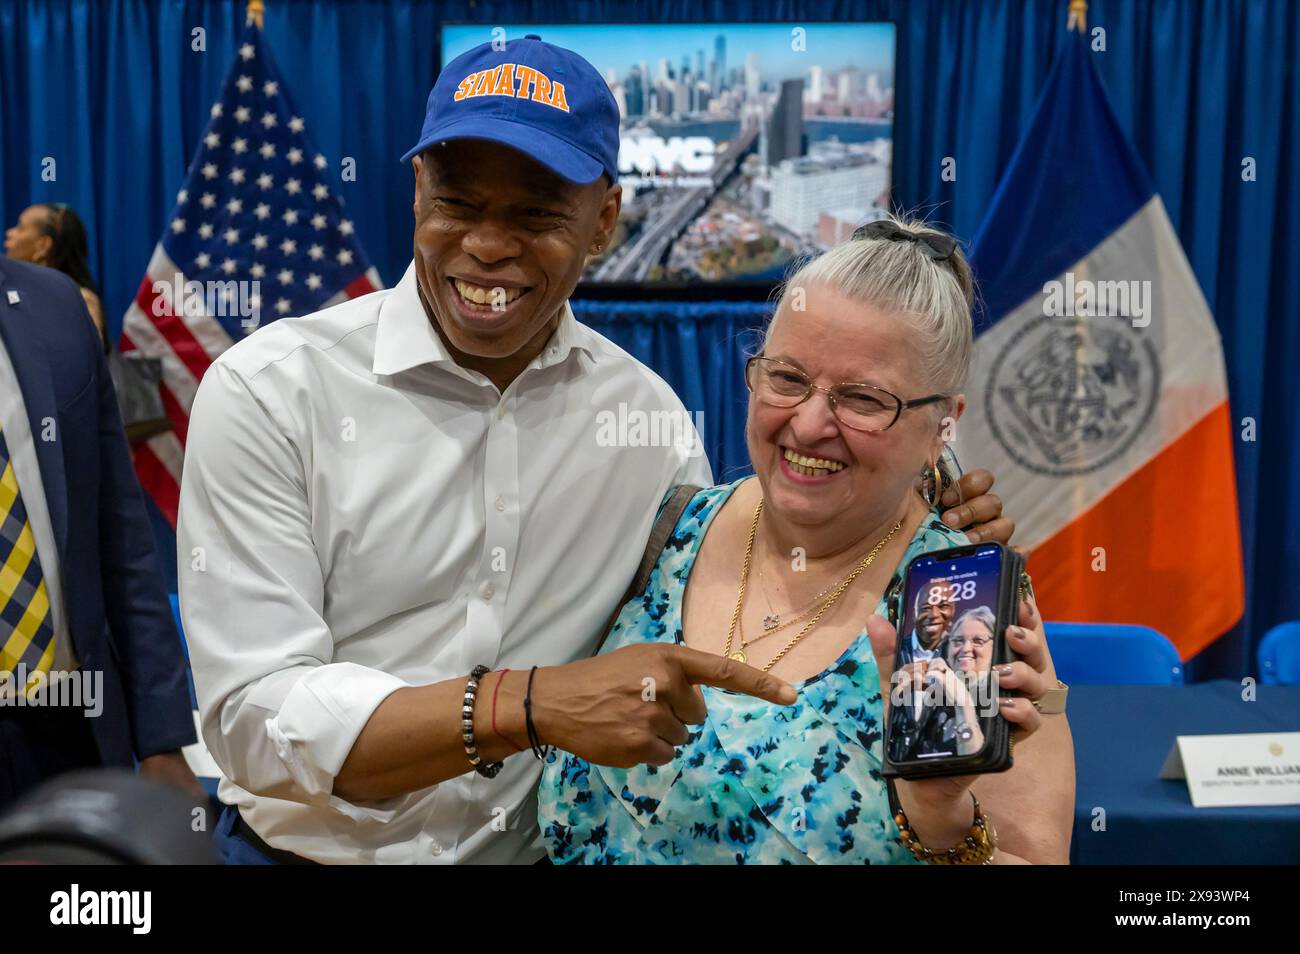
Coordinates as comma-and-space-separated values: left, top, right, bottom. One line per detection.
1044, 623, 1183, 686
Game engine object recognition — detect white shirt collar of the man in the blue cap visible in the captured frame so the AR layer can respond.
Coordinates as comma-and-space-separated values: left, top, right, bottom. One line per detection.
371, 261, 595, 374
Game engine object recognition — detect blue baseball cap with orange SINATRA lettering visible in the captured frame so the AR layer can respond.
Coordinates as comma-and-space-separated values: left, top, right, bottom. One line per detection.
402, 34, 619, 183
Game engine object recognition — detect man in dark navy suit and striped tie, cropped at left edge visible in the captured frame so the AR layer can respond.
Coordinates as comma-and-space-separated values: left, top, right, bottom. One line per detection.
0, 257, 204, 808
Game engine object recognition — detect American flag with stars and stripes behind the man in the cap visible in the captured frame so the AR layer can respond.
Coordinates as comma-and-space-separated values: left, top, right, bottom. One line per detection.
120, 23, 382, 526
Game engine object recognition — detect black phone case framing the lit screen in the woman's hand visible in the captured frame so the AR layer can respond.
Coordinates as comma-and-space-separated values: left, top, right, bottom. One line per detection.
880, 543, 1024, 779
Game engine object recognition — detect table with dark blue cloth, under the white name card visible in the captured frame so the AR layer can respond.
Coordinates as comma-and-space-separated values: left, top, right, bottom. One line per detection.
1069, 680, 1300, 864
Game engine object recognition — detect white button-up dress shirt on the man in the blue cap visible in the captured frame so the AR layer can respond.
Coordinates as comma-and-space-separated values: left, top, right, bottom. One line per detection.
178, 266, 711, 863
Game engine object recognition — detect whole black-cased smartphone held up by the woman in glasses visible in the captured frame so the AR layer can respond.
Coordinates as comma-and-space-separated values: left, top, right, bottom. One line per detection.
881, 543, 1023, 779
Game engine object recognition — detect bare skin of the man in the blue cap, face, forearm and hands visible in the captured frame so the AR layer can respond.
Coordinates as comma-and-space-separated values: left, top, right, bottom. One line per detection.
334, 139, 1010, 802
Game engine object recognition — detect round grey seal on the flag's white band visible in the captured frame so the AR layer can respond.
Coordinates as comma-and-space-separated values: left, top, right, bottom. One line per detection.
984, 316, 1160, 477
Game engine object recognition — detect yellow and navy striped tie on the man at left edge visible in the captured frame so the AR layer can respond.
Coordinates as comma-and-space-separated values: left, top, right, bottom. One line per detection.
0, 430, 55, 693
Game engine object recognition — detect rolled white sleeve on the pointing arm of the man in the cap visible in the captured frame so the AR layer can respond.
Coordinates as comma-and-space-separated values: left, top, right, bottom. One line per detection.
177, 360, 407, 821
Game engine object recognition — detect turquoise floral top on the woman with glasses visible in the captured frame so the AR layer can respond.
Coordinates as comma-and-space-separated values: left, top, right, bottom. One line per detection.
538, 481, 966, 864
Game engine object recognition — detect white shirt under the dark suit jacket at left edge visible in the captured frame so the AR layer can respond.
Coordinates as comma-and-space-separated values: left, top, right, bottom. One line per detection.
0, 341, 77, 675
